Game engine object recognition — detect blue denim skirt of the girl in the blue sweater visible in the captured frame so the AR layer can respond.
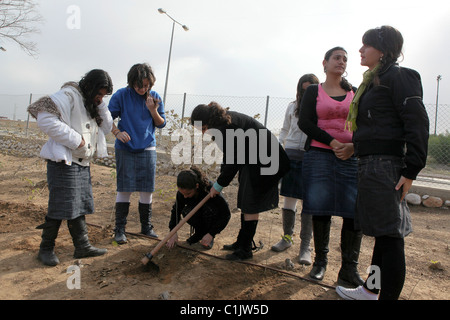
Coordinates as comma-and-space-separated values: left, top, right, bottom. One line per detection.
115, 149, 156, 192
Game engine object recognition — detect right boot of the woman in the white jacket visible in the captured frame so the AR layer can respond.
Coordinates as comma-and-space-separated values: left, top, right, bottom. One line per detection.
67, 216, 108, 259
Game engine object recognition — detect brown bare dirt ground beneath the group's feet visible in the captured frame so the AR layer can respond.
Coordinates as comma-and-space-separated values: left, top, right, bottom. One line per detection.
0, 154, 450, 300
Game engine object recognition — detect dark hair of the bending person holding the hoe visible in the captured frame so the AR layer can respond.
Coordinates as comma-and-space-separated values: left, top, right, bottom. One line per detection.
191, 102, 231, 128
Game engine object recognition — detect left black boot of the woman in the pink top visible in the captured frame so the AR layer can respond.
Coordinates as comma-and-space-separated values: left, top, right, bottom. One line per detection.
309, 219, 331, 281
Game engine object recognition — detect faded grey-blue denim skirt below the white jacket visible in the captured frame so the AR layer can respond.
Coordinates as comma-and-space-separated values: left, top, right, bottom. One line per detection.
47, 160, 94, 220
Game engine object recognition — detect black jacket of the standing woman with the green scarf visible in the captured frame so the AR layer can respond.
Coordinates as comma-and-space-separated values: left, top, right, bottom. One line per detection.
353, 64, 429, 179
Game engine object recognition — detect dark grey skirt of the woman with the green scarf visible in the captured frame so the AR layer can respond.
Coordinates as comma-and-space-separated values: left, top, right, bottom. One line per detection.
355, 155, 412, 238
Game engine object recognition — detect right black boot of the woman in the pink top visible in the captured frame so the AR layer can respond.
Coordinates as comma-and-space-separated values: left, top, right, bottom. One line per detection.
338, 229, 364, 288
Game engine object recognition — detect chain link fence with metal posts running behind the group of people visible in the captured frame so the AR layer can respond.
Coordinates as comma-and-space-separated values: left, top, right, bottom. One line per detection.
0, 94, 450, 190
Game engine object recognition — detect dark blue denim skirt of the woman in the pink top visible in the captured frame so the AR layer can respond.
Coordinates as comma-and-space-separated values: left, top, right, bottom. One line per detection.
302, 148, 358, 218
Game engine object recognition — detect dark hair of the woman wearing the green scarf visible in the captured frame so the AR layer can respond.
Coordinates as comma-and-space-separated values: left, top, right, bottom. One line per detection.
362, 26, 403, 70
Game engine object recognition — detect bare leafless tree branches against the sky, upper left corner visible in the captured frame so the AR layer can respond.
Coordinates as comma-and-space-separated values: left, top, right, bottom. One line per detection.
0, 0, 43, 56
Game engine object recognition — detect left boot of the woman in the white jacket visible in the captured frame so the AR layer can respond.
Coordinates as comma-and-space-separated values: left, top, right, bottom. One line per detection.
36, 217, 61, 267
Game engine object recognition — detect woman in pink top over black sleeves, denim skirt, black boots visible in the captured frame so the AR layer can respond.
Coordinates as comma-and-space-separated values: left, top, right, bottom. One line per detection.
298, 47, 363, 287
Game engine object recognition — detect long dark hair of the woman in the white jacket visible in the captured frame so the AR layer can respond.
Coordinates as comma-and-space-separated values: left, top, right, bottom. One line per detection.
78, 69, 113, 126
